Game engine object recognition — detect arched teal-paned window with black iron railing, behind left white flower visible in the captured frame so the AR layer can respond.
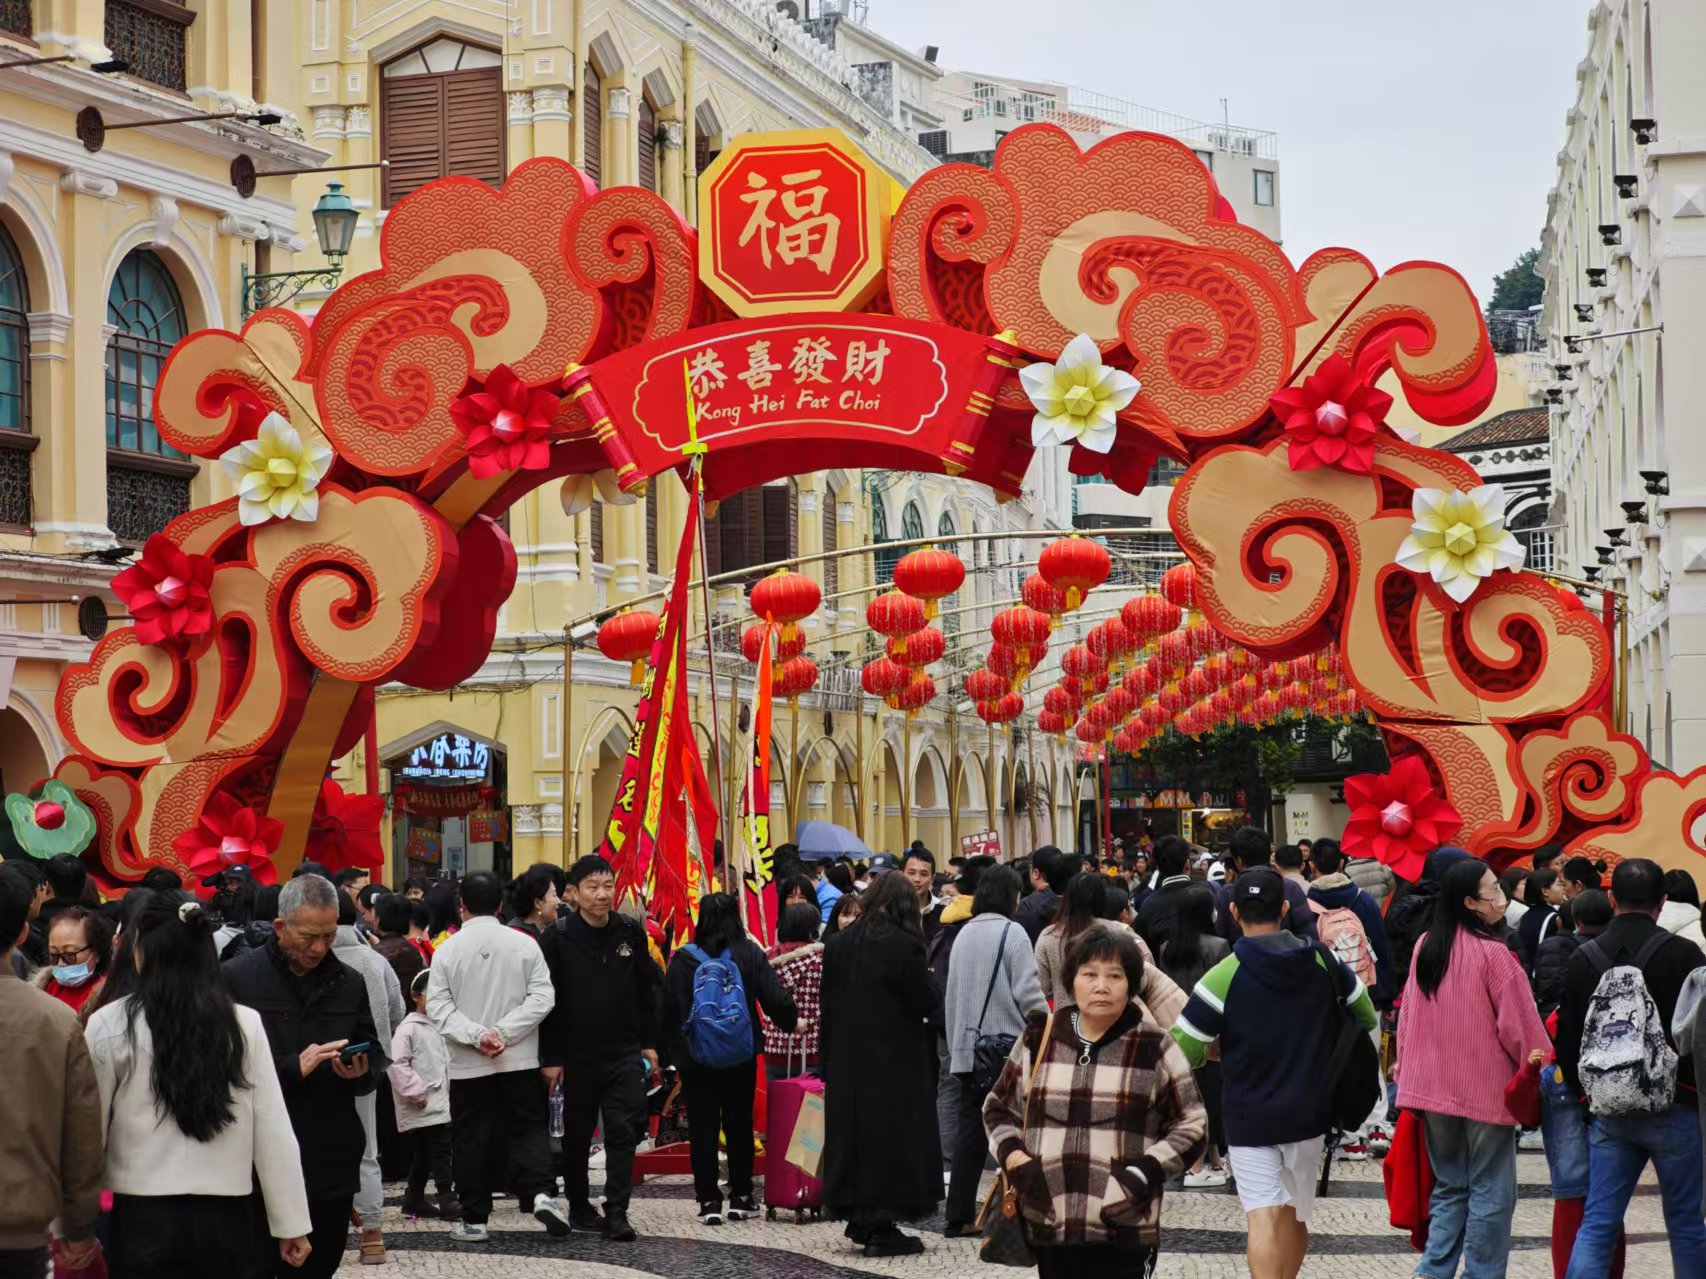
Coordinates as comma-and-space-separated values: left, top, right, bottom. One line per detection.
106, 249, 194, 542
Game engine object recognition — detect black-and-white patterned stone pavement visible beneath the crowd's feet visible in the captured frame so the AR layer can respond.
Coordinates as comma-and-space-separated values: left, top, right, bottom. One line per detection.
339, 1153, 1672, 1279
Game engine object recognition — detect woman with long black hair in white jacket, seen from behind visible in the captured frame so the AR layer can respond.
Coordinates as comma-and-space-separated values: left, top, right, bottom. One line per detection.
87, 890, 309, 1279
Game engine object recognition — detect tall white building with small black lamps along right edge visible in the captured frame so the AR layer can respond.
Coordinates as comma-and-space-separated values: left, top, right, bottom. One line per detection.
1541, 0, 1706, 771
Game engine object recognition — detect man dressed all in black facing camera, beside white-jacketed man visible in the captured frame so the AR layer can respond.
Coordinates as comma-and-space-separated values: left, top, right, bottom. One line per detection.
539, 856, 660, 1243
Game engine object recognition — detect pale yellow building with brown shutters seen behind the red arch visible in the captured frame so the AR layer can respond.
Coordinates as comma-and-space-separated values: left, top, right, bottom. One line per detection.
263, 0, 1073, 882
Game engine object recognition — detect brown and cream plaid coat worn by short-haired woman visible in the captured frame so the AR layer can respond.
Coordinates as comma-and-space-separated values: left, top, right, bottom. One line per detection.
983, 1006, 1208, 1247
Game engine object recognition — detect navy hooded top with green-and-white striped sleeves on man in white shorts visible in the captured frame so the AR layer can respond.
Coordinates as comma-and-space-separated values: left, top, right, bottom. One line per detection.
1172, 931, 1377, 1146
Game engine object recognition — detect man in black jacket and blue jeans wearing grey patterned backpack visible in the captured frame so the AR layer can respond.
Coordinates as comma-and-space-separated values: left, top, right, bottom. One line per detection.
1558, 858, 1706, 1276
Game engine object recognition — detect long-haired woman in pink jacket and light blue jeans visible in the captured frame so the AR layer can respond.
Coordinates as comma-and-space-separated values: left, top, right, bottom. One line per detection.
1397, 858, 1551, 1279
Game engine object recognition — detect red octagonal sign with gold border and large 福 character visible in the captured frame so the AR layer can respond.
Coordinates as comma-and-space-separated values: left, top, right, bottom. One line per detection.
694, 130, 892, 315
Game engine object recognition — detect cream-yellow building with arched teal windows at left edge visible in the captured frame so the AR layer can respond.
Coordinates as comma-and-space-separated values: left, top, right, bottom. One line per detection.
0, 0, 326, 793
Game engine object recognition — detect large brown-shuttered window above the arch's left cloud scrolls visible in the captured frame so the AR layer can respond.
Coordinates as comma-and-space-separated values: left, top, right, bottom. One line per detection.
379, 38, 508, 206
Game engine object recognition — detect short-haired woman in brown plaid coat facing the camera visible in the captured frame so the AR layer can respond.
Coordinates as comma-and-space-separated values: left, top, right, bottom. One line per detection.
983, 929, 1208, 1279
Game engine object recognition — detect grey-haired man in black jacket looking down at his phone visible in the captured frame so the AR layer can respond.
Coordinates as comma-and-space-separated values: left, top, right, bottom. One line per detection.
223, 875, 384, 1279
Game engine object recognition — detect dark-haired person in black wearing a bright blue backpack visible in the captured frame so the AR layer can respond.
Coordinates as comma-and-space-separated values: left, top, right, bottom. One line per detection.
662, 892, 798, 1226
